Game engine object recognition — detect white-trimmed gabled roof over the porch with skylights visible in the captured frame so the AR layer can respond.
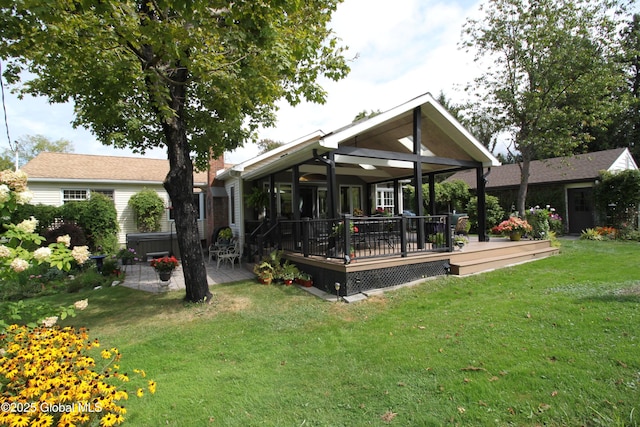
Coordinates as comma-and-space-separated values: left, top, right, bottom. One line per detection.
218, 93, 500, 183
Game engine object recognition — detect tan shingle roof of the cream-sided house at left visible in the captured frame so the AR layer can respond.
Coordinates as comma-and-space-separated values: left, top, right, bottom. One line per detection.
22, 152, 207, 185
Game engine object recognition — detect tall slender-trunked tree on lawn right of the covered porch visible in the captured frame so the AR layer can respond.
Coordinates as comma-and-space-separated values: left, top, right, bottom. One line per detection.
463, 0, 621, 214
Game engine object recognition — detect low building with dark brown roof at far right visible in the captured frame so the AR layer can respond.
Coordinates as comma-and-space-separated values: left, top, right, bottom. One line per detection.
447, 148, 638, 234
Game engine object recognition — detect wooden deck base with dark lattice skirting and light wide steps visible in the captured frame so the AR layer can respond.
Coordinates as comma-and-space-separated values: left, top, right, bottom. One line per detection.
284, 237, 559, 296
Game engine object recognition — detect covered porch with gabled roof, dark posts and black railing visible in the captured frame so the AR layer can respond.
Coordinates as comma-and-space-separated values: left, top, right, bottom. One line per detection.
217, 94, 552, 295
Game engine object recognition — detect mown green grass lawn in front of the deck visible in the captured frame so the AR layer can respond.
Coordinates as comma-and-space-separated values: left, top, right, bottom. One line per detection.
12, 241, 640, 426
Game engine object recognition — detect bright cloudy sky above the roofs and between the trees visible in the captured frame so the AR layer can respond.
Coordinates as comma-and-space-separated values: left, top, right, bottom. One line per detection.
0, 0, 481, 163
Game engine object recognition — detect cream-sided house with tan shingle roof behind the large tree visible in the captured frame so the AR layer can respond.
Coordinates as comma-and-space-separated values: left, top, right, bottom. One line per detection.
22, 153, 226, 245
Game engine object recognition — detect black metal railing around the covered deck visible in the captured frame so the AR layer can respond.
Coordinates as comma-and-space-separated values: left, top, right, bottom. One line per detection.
248, 215, 452, 263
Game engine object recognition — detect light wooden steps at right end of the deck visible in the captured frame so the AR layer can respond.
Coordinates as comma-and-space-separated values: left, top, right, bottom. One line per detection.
450, 240, 559, 276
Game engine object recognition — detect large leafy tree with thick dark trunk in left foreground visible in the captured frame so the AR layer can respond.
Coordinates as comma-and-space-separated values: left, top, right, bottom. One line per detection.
0, 0, 348, 301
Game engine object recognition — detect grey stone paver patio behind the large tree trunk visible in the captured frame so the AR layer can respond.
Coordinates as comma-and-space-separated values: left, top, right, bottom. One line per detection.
122, 263, 256, 292
